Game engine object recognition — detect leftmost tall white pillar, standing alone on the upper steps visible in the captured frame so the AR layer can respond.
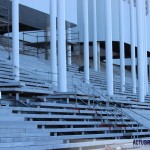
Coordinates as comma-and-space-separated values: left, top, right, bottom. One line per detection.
12, 0, 20, 81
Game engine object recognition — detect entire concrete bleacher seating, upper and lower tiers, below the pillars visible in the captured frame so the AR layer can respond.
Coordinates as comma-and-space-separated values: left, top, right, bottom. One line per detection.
0, 40, 150, 150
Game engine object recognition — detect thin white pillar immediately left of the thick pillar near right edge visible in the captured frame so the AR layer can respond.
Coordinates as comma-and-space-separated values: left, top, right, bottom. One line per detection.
130, 0, 136, 94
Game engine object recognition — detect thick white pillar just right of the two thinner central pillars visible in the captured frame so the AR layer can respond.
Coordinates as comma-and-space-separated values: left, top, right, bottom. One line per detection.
105, 0, 113, 96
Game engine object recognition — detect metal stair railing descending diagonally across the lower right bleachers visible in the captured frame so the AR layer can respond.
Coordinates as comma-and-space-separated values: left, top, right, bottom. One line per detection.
75, 86, 150, 138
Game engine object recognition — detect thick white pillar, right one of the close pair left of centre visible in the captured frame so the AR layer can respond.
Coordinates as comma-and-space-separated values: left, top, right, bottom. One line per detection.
57, 0, 67, 92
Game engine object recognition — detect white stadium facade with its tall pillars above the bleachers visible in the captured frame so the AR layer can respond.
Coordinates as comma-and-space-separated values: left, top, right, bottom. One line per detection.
7, 0, 150, 102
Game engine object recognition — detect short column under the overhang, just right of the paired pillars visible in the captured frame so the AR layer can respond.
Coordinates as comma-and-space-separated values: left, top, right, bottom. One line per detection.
67, 29, 72, 65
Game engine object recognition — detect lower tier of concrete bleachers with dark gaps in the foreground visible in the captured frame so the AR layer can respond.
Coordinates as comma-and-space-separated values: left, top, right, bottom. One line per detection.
0, 94, 150, 149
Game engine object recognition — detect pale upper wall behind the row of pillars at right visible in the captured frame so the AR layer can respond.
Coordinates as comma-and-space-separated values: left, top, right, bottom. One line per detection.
77, 0, 139, 44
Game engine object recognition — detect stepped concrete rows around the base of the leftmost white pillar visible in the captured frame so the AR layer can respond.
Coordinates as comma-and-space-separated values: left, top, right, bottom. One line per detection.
0, 62, 53, 94
